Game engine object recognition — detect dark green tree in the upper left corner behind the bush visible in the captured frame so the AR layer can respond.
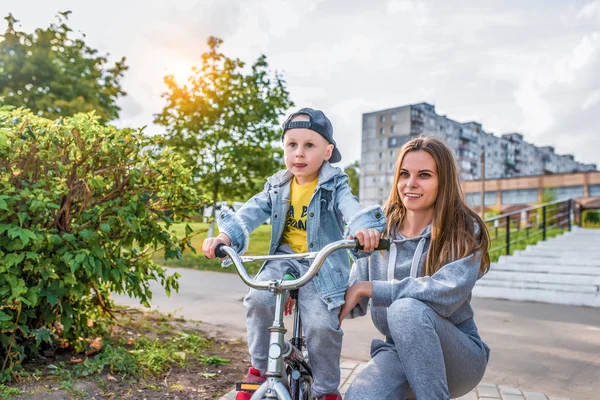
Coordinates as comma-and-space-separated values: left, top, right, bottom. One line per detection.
0, 11, 128, 121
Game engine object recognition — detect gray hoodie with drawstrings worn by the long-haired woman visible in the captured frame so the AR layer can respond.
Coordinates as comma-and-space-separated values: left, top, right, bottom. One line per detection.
349, 225, 489, 357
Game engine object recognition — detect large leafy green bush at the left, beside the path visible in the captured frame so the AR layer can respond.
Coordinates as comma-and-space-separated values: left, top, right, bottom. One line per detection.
0, 107, 202, 381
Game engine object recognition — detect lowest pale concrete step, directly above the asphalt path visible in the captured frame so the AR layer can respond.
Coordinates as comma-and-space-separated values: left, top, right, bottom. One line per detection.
473, 280, 600, 307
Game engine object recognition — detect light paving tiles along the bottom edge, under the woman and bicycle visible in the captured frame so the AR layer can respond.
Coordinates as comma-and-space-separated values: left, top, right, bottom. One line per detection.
219, 360, 569, 400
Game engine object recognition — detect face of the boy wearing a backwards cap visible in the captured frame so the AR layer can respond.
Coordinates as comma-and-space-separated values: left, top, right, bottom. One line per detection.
283, 122, 333, 185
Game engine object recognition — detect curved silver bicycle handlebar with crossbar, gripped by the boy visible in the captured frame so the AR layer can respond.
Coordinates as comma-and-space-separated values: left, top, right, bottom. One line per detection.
215, 239, 390, 290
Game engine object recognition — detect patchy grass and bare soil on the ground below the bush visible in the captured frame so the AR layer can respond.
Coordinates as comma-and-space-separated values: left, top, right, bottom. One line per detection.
0, 309, 247, 400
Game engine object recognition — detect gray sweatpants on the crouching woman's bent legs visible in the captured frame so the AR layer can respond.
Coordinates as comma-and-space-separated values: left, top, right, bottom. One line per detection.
345, 298, 487, 400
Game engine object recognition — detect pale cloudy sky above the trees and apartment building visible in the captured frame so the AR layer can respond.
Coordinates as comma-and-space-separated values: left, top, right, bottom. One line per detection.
0, 0, 600, 167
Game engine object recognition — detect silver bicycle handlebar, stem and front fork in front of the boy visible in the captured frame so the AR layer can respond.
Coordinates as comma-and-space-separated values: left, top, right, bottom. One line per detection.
215, 239, 389, 400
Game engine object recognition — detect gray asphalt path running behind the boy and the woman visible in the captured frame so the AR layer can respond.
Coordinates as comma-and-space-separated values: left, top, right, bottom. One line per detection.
115, 269, 600, 400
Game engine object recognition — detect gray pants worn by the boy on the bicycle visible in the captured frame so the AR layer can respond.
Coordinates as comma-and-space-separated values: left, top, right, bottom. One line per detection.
244, 245, 343, 397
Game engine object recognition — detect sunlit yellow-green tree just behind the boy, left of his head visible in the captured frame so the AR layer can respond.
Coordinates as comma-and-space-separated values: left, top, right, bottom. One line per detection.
155, 37, 293, 217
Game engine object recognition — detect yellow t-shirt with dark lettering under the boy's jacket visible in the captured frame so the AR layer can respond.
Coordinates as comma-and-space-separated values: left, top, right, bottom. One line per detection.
281, 177, 319, 253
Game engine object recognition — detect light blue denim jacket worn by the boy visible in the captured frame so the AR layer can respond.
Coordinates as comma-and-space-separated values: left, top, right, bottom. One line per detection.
217, 162, 385, 310
